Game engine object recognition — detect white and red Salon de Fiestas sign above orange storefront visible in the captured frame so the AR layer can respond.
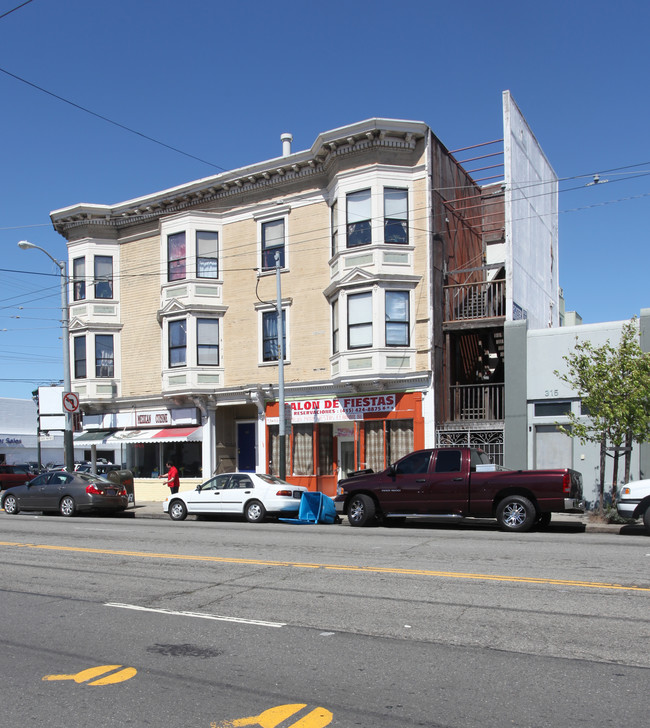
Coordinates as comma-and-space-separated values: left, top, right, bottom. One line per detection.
266, 394, 397, 425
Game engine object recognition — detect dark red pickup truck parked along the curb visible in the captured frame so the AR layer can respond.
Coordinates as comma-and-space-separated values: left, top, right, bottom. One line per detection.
334, 447, 584, 532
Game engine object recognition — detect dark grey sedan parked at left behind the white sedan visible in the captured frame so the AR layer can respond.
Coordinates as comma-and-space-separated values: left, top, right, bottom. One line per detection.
2, 470, 129, 516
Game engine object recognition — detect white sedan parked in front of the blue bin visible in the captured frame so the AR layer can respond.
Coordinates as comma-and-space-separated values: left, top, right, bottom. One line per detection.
163, 473, 307, 523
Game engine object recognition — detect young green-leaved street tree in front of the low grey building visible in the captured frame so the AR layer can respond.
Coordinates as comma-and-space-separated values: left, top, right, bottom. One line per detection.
555, 318, 650, 513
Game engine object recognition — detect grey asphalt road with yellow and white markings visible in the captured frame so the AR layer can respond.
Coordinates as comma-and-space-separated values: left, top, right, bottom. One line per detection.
0, 514, 650, 728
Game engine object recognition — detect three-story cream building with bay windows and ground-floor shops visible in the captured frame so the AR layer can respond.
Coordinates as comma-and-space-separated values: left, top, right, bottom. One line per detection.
51, 92, 559, 494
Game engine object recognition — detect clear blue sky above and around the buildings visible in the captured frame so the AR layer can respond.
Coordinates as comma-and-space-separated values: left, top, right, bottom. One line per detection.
0, 0, 650, 398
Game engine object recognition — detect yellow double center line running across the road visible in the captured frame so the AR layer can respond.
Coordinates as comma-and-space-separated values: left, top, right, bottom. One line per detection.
0, 541, 650, 592
